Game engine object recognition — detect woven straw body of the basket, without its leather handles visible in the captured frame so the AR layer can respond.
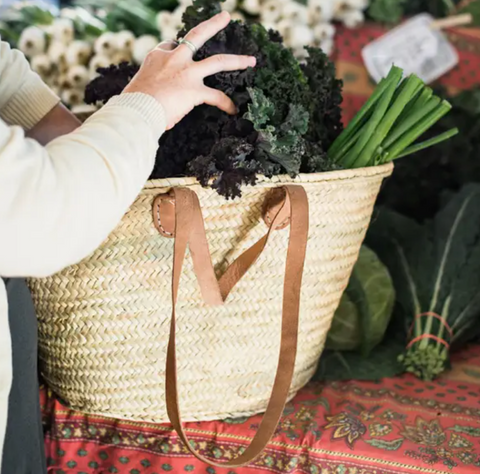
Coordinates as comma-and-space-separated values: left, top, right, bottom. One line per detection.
30, 165, 392, 422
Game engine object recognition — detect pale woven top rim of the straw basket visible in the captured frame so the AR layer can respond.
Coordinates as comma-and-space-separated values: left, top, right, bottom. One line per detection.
144, 162, 393, 190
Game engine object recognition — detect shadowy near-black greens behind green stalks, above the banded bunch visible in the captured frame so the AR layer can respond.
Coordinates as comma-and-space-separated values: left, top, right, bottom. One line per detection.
378, 88, 480, 222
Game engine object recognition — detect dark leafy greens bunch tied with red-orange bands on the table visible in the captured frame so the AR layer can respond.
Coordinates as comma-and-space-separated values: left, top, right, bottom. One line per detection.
366, 184, 480, 380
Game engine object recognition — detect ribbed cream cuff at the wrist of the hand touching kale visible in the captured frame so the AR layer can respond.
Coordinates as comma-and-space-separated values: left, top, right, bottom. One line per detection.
105, 92, 167, 138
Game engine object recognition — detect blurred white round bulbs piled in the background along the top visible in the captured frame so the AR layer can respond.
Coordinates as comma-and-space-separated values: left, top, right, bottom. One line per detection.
4, 0, 369, 101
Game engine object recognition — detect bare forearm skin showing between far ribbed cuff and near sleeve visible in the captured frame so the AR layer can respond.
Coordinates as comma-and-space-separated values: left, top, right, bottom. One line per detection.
26, 104, 81, 146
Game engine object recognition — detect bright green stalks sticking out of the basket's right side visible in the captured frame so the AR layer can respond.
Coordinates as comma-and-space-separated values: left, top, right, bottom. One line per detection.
328, 66, 458, 168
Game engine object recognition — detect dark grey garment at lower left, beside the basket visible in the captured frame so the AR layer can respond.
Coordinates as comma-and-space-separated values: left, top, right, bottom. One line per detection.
1, 279, 47, 474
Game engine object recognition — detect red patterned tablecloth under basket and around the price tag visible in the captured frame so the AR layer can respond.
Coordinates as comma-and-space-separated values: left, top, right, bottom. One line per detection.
40, 25, 480, 474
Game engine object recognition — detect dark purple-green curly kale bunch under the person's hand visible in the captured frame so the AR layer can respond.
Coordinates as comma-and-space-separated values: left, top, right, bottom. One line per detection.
85, 0, 342, 198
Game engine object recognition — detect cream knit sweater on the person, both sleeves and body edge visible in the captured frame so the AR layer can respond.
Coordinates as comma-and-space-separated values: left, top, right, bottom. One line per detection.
0, 38, 165, 466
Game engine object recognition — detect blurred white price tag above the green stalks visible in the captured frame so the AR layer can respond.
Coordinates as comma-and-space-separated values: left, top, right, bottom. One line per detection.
362, 13, 458, 84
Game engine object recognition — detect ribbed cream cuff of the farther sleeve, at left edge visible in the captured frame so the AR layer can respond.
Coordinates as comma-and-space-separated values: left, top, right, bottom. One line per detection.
0, 72, 60, 130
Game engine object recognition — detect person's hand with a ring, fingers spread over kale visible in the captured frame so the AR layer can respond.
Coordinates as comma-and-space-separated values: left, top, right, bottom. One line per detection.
123, 12, 256, 130
